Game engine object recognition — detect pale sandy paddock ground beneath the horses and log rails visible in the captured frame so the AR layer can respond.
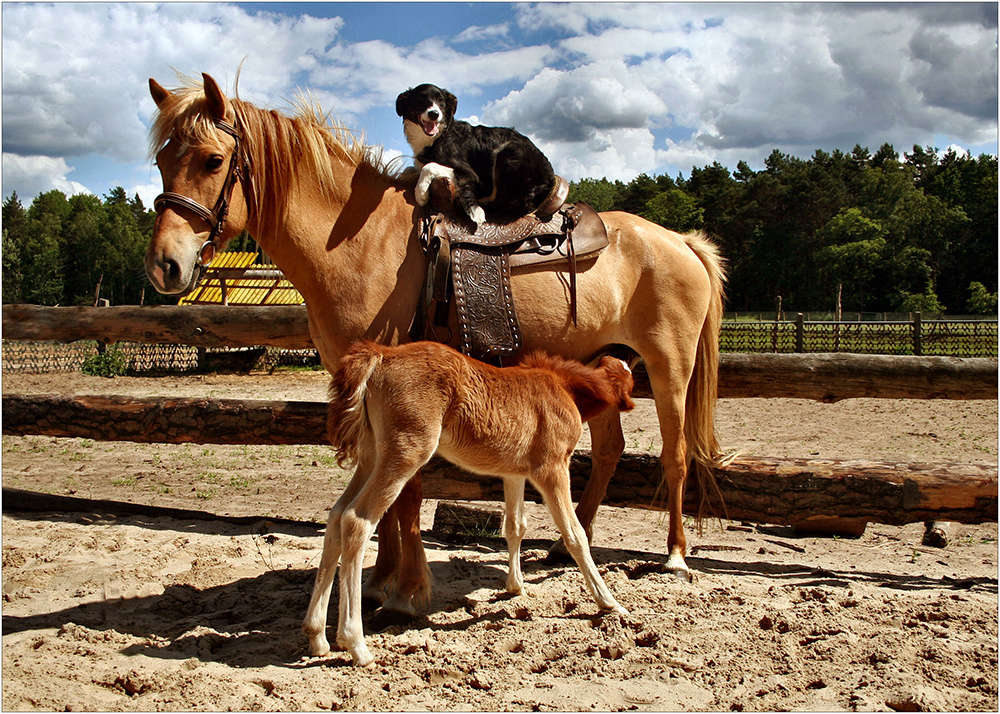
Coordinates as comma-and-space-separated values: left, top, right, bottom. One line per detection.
2, 373, 998, 711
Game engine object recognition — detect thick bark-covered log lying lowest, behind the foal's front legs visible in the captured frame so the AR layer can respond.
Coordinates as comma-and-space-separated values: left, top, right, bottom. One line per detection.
424, 452, 997, 530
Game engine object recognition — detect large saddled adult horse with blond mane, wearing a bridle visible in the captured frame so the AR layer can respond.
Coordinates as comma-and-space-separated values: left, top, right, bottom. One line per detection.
145, 69, 724, 615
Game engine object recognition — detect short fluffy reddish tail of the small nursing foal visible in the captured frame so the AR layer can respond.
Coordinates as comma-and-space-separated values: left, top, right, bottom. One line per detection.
326, 342, 382, 467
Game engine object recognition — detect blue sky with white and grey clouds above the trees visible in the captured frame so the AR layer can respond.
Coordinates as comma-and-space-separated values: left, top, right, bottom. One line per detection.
2, 2, 997, 205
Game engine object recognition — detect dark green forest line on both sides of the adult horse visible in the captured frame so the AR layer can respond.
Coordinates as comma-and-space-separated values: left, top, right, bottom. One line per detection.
2, 144, 997, 314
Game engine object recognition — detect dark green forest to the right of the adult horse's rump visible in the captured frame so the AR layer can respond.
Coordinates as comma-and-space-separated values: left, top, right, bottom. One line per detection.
570, 144, 997, 314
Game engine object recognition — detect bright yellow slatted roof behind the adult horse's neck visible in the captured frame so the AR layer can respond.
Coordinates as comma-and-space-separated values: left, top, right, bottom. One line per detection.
178, 252, 305, 305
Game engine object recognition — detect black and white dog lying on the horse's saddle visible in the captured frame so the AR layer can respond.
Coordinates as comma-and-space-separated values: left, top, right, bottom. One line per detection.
396, 84, 556, 225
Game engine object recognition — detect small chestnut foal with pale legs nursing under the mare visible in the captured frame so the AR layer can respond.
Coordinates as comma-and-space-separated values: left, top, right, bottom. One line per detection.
302, 341, 635, 666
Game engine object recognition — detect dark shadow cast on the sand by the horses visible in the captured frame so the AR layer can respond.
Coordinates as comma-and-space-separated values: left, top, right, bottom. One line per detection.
3, 514, 997, 668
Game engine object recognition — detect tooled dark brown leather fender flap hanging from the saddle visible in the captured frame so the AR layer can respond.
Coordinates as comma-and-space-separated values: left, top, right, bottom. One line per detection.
451, 246, 521, 359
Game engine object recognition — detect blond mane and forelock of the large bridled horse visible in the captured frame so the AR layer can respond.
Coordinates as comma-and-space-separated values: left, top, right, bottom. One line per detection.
150, 75, 412, 228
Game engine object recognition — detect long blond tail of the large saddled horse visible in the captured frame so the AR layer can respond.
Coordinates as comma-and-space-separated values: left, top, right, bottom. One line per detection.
684, 233, 735, 515
